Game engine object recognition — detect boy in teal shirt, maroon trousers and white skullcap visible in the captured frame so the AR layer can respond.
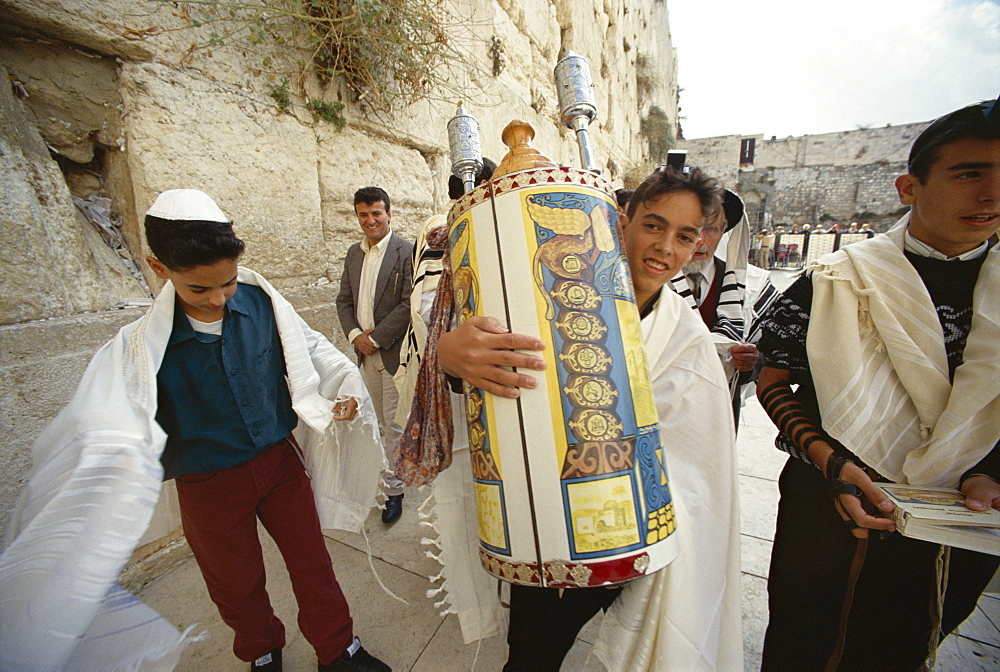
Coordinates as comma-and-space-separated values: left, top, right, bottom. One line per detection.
145, 189, 389, 672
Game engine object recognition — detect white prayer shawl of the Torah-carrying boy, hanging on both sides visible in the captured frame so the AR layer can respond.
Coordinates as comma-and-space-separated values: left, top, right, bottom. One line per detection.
428, 292, 743, 671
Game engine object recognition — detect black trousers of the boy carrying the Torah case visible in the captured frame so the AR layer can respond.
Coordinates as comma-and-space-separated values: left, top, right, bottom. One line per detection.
503, 584, 621, 672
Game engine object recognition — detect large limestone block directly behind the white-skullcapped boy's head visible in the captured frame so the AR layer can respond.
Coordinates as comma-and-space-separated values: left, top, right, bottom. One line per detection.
121, 63, 326, 287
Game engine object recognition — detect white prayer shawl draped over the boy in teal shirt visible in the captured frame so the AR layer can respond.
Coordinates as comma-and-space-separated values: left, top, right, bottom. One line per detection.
0, 268, 384, 672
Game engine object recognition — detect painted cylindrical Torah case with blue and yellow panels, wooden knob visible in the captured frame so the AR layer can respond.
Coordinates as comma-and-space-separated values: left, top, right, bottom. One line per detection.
448, 122, 678, 588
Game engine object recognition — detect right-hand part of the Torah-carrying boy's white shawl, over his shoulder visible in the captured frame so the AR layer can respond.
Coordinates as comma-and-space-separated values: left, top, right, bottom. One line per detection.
594, 292, 743, 671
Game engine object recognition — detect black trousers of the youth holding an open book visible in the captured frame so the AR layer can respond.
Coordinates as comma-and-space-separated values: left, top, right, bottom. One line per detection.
761, 458, 1000, 670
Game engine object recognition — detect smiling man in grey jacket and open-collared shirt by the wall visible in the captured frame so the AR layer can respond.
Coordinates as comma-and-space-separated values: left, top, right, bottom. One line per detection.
337, 187, 413, 524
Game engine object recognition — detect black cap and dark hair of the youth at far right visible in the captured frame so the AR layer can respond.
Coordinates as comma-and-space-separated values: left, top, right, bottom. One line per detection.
906, 98, 1000, 184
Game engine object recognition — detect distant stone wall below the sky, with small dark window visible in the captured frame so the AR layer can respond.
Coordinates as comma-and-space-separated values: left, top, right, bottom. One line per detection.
678, 122, 930, 230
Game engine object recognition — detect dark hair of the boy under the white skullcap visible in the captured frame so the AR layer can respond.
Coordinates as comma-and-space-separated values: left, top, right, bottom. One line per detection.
145, 215, 246, 271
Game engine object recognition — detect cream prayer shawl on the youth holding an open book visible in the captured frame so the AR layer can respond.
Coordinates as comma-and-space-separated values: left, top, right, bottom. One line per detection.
806, 215, 1000, 487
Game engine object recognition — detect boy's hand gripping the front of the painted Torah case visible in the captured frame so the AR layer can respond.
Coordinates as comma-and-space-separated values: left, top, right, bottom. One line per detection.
437, 316, 545, 399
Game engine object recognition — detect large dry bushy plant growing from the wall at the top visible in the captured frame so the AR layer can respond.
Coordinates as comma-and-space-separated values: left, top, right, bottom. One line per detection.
147, 0, 484, 117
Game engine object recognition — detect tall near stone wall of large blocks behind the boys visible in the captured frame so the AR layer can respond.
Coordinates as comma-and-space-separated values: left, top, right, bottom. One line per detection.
0, 0, 677, 552
